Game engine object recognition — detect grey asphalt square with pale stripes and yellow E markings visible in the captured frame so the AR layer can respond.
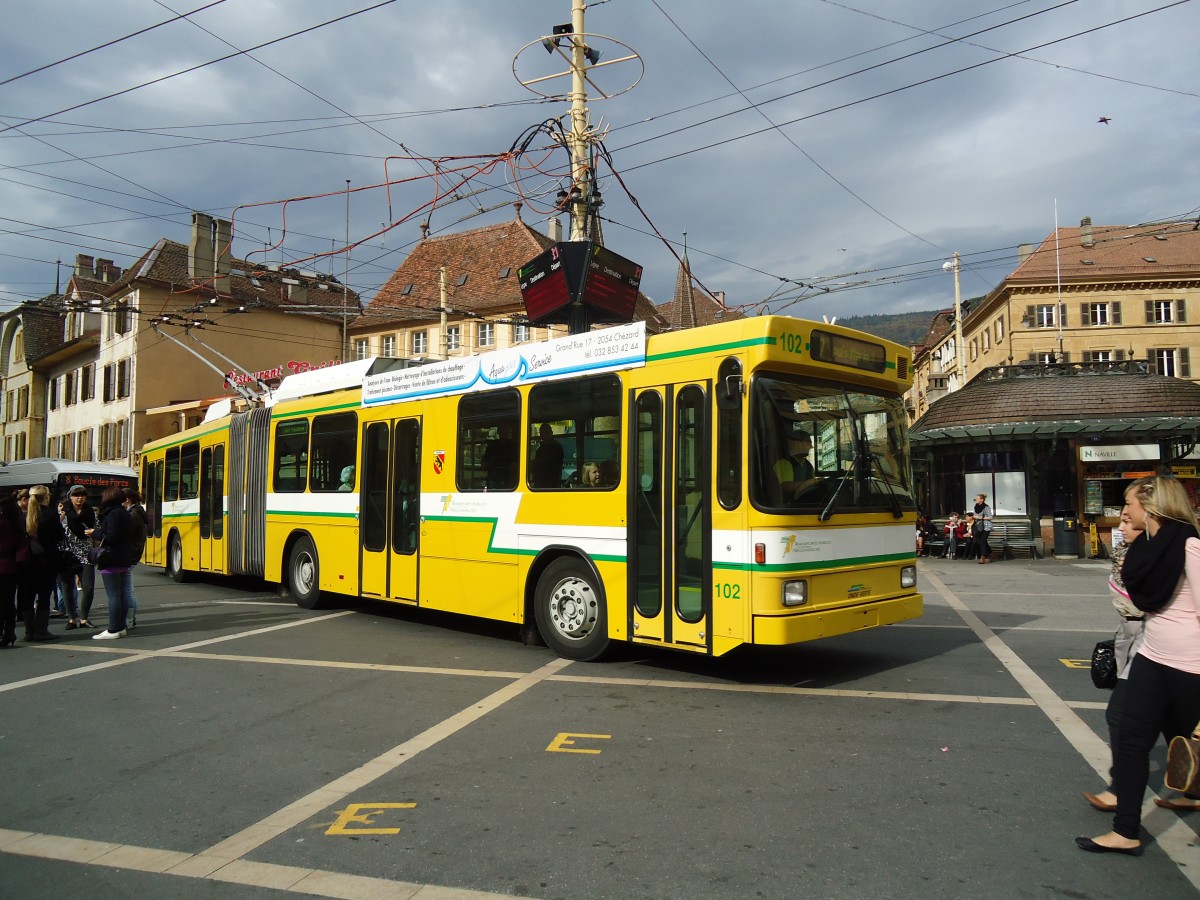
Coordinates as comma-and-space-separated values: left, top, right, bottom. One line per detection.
0, 559, 1200, 900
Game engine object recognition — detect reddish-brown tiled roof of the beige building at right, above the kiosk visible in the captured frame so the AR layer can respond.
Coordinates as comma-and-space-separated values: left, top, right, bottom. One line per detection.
1007, 222, 1200, 284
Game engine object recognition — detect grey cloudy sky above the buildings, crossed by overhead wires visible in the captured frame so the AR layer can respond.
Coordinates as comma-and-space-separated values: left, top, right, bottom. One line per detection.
0, 0, 1200, 318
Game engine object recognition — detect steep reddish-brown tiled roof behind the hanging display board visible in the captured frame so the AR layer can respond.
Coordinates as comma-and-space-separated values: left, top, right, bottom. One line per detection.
350, 218, 666, 331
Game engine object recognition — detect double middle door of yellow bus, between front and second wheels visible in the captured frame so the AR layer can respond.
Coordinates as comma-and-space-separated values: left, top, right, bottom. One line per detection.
359, 419, 421, 602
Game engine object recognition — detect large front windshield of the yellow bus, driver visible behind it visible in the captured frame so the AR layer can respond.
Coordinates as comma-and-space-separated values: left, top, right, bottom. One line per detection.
750, 374, 916, 520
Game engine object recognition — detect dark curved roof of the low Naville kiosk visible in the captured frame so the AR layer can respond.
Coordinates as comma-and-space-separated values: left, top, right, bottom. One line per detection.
911, 364, 1200, 434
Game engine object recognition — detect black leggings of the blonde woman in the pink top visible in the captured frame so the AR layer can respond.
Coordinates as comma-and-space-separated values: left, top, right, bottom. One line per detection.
1112, 653, 1200, 840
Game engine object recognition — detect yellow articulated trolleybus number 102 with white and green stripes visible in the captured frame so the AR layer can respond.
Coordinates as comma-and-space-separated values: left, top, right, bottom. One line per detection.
140, 317, 922, 660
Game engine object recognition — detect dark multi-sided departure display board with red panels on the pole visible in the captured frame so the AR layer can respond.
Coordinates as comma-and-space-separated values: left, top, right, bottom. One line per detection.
517, 241, 642, 325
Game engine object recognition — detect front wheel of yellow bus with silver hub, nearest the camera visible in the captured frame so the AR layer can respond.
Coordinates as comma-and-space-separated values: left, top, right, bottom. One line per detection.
534, 558, 608, 662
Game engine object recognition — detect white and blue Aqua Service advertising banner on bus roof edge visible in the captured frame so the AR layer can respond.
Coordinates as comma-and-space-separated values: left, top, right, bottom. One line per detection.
362, 322, 646, 406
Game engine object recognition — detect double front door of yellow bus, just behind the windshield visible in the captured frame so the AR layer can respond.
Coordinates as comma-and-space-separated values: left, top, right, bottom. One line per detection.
629, 384, 713, 652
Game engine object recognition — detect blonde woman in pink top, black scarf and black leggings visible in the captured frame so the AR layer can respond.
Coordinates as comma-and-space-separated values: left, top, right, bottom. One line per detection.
1075, 475, 1200, 856
